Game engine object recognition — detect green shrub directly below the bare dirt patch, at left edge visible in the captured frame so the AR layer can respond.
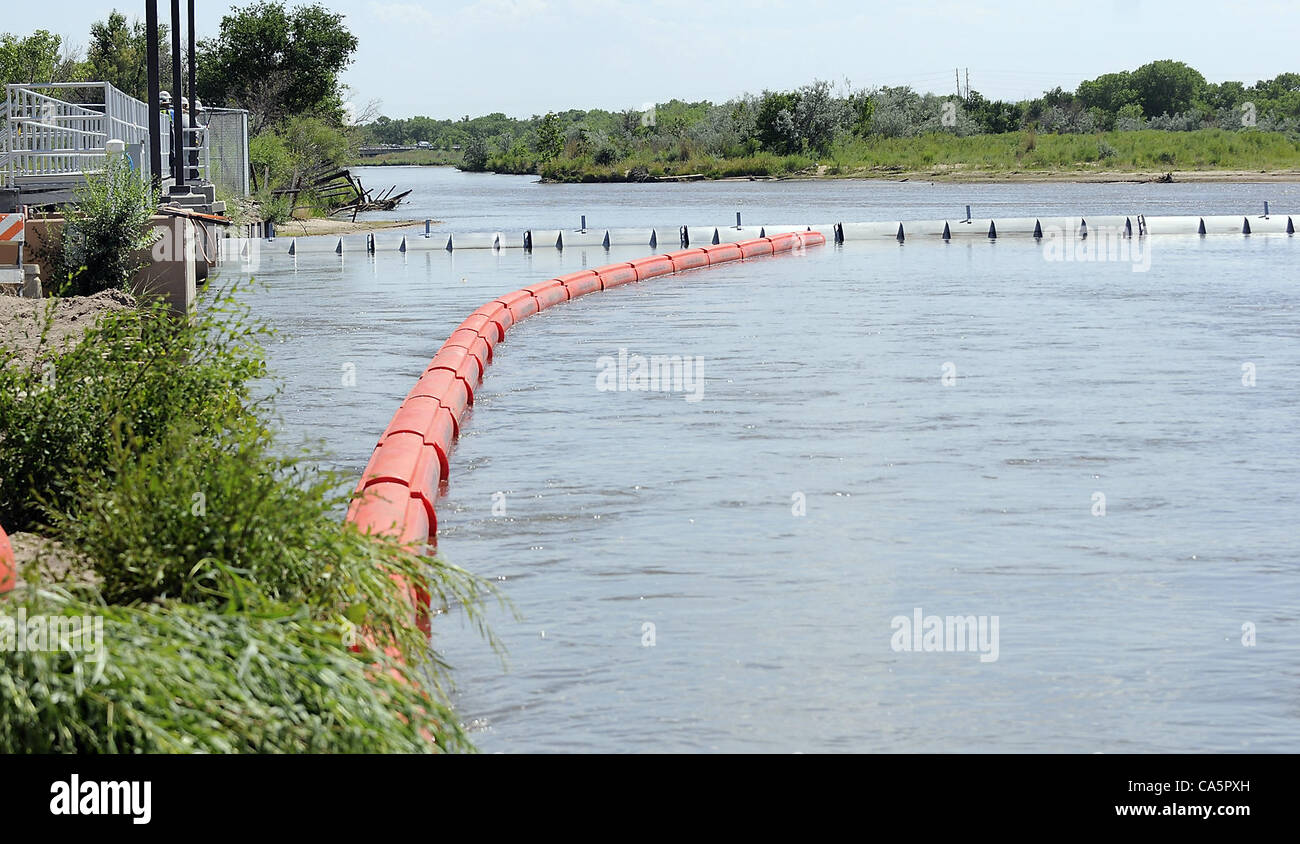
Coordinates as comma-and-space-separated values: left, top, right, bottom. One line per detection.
0, 291, 268, 531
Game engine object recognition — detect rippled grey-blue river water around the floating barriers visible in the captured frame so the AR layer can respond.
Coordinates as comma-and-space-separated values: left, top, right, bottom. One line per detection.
226, 168, 1300, 752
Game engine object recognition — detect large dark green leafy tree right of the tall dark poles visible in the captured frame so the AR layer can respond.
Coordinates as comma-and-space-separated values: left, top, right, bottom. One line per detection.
198, 0, 358, 134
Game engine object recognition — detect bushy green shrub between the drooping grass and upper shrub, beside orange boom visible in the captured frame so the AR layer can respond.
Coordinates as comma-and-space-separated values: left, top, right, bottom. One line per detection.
51, 413, 496, 662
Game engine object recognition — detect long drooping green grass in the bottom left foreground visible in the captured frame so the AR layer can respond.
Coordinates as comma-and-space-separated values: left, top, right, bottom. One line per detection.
0, 589, 472, 753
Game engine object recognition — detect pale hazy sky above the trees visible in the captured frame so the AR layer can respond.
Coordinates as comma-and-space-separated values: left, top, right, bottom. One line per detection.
10, 0, 1300, 117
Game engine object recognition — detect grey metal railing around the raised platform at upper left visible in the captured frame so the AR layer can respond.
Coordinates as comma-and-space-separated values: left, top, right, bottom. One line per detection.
0, 82, 150, 187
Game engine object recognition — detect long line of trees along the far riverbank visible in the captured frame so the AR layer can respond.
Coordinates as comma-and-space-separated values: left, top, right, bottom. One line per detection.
364, 60, 1300, 173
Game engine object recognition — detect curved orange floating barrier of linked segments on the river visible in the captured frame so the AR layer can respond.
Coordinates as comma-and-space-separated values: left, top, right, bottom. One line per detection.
348, 231, 826, 633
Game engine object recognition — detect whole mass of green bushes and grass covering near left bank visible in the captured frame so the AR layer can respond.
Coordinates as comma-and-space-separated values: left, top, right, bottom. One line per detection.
0, 283, 495, 752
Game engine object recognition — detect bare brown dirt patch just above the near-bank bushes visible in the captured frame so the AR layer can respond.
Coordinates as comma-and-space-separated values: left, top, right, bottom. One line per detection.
0, 290, 135, 365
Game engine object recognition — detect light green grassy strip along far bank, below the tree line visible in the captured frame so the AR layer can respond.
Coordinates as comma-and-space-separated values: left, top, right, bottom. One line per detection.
522, 129, 1300, 182
